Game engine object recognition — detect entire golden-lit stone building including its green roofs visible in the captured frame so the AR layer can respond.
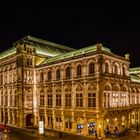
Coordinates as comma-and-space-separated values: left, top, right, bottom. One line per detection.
0, 36, 140, 136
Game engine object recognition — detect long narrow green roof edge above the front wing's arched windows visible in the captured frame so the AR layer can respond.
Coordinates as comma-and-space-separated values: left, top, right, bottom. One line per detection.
42, 45, 111, 64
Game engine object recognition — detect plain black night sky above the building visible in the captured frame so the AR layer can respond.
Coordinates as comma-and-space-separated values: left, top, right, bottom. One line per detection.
0, 1, 140, 67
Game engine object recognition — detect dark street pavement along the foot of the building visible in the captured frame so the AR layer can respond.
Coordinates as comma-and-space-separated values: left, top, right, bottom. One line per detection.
0, 128, 140, 140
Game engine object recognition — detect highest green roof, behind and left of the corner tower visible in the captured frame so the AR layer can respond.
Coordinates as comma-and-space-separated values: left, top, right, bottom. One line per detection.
0, 36, 75, 59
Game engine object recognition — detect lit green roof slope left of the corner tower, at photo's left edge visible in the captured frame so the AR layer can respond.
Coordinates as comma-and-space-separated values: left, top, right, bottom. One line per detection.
0, 47, 16, 59
